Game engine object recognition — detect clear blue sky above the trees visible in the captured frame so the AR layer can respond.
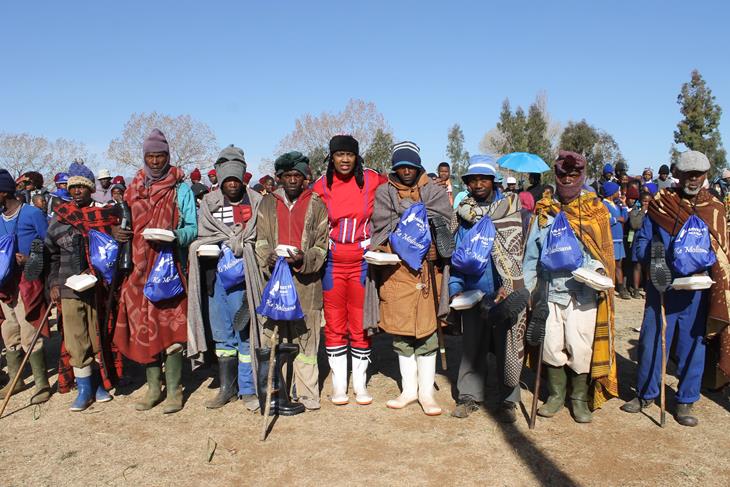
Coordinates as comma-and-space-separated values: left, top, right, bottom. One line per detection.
0, 0, 730, 177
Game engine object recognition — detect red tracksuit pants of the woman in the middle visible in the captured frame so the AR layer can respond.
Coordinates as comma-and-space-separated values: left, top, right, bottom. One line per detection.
322, 248, 370, 358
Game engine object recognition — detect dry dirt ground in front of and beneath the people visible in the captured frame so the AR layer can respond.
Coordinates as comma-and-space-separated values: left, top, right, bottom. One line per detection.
0, 300, 730, 486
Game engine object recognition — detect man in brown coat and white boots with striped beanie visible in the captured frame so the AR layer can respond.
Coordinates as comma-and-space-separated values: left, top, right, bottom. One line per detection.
365, 142, 452, 416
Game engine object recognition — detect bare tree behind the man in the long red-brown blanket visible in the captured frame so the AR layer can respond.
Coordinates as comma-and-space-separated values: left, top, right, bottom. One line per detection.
107, 112, 218, 171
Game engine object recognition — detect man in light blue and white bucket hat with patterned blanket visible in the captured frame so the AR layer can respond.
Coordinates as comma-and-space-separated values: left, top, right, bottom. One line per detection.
449, 156, 526, 423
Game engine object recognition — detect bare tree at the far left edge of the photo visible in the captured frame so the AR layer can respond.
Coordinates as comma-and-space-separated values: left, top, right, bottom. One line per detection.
0, 133, 95, 178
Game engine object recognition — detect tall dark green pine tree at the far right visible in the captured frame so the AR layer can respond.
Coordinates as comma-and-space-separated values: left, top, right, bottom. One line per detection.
674, 69, 727, 174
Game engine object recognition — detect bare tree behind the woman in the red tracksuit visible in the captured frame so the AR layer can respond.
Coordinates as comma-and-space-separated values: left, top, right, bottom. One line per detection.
276, 99, 391, 174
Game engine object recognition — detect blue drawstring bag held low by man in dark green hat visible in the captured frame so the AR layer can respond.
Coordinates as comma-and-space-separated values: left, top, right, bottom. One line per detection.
256, 257, 304, 321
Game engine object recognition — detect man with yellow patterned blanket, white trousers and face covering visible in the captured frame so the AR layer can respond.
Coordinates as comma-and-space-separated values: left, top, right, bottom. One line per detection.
524, 151, 618, 423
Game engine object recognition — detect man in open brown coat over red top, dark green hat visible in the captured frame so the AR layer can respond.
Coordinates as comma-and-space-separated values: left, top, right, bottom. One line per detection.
256, 152, 329, 410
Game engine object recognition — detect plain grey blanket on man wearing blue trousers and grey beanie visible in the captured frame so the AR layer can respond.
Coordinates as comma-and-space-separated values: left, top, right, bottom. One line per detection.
188, 187, 264, 370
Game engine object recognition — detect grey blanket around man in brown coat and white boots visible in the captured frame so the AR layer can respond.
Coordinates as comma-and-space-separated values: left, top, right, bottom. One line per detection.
363, 181, 453, 335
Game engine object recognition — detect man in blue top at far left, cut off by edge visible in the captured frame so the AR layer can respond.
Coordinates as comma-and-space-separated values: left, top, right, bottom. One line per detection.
0, 169, 51, 404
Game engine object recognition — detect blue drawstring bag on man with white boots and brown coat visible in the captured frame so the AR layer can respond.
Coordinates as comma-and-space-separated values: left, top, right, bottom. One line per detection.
390, 203, 431, 271
